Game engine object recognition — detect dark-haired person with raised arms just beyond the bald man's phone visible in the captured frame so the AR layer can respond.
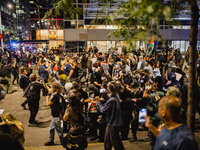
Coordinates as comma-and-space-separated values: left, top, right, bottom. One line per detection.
143, 76, 164, 149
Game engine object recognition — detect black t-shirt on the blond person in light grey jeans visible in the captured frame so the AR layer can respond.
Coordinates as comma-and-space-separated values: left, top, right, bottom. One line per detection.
50, 93, 63, 117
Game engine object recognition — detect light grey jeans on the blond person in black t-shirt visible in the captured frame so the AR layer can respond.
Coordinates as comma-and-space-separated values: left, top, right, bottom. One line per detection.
49, 117, 63, 145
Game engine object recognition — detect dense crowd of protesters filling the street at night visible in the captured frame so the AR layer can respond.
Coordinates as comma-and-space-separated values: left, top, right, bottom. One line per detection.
0, 47, 200, 150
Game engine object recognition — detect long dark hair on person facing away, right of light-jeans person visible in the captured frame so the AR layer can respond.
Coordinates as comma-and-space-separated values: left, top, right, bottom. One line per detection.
67, 90, 83, 115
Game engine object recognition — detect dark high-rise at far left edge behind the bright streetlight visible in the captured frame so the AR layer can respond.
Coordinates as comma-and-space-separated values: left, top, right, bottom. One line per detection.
0, 0, 17, 47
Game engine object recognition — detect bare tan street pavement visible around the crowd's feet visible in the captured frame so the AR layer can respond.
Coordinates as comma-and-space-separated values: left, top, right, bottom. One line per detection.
0, 81, 200, 150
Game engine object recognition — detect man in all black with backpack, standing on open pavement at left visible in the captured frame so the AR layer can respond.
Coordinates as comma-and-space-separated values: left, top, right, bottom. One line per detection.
27, 74, 46, 127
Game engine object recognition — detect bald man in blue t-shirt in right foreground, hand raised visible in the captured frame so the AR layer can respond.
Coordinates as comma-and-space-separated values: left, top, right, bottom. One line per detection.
145, 96, 198, 150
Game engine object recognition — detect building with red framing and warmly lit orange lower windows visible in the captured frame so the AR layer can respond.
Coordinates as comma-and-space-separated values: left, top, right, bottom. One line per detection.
30, 0, 64, 48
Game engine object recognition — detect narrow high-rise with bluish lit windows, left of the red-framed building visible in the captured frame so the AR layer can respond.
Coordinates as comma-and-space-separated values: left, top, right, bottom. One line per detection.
16, 0, 31, 42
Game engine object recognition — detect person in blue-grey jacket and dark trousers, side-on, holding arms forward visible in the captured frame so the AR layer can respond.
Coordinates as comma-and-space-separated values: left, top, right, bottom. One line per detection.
95, 81, 124, 150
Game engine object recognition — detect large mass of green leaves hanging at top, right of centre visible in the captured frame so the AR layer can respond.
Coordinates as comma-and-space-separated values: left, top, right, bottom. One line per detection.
92, 0, 186, 46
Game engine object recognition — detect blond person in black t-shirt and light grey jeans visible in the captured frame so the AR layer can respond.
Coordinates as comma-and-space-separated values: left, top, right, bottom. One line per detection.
44, 82, 64, 146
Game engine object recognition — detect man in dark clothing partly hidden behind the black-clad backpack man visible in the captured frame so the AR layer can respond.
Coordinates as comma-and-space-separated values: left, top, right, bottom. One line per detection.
20, 69, 31, 109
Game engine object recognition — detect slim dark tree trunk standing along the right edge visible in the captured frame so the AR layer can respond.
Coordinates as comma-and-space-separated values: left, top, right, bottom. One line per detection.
187, 0, 199, 132
